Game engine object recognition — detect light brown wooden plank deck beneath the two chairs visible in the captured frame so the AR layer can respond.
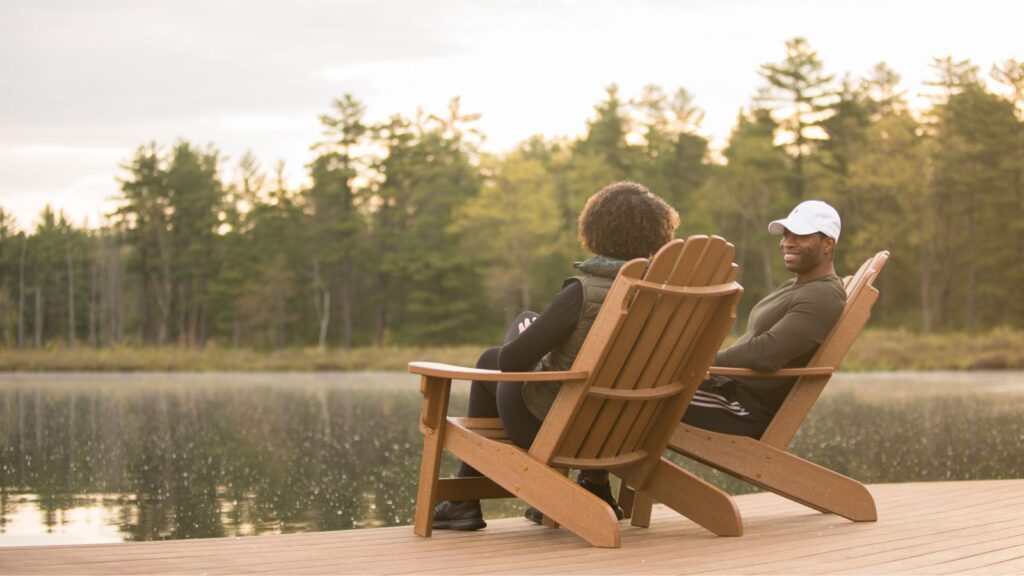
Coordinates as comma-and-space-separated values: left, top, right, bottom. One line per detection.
0, 480, 1024, 574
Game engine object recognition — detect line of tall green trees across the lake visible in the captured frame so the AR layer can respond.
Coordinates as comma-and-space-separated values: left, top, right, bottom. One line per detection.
0, 38, 1024, 348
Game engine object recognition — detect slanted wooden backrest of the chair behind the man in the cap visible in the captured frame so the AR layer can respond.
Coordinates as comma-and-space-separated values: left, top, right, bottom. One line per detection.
761, 250, 889, 449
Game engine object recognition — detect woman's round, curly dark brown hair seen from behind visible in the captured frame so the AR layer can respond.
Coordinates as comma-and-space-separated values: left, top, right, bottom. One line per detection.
580, 181, 679, 260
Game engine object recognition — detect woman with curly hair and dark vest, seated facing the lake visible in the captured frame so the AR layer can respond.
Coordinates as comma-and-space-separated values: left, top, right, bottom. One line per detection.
433, 181, 679, 530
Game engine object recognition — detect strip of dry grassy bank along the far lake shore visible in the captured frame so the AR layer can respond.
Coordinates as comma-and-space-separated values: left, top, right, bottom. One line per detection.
0, 330, 1024, 371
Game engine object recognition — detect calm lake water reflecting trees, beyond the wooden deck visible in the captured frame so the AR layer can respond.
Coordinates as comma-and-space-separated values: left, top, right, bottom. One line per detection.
0, 372, 1024, 546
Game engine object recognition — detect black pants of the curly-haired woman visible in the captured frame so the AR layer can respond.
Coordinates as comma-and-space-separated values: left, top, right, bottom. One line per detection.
456, 312, 541, 478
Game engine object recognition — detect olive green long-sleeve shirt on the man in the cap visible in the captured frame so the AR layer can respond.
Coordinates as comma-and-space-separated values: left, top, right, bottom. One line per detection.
715, 274, 846, 414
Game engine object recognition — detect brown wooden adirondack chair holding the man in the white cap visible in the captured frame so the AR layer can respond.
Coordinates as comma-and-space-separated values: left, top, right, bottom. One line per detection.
620, 251, 889, 526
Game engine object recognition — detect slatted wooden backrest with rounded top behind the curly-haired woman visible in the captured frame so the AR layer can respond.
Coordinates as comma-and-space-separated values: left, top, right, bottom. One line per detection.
530, 236, 742, 469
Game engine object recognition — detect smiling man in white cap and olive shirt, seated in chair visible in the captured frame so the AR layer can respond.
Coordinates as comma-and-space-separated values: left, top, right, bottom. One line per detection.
683, 200, 846, 438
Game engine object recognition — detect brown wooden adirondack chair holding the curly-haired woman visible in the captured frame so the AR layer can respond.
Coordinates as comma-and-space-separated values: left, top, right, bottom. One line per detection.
409, 236, 742, 547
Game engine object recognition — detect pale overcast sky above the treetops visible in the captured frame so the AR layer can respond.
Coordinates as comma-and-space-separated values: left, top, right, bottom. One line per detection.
0, 0, 1024, 227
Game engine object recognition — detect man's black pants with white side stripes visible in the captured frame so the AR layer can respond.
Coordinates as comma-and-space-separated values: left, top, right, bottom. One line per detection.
683, 376, 771, 438
